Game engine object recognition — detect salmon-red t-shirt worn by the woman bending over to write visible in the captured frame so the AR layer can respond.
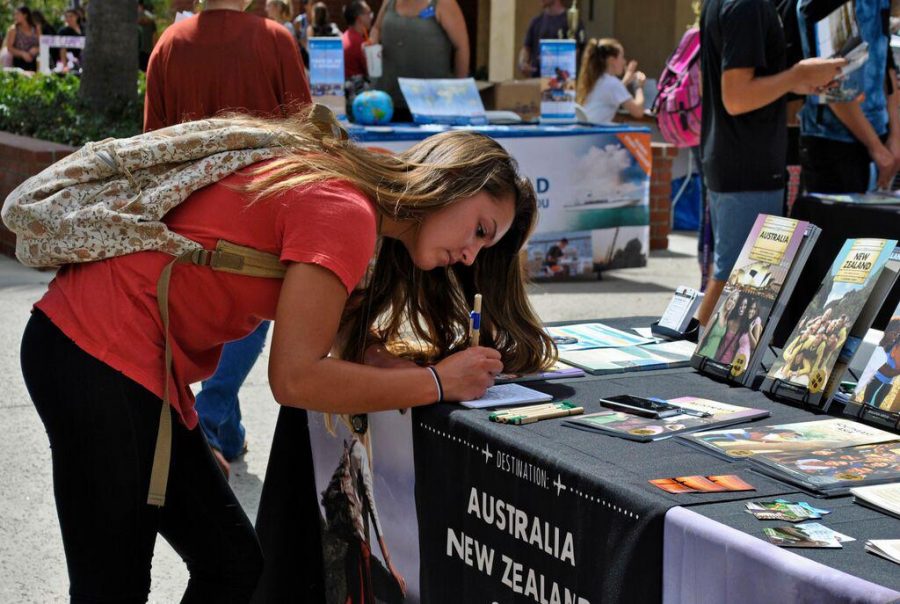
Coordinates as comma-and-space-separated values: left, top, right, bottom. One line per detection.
35, 166, 376, 428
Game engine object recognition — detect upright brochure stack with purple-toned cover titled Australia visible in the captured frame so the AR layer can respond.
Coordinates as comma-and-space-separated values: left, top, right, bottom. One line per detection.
691, 214, 821, 386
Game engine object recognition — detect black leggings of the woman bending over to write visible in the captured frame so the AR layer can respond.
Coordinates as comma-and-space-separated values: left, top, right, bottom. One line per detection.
22, 310, 262, 603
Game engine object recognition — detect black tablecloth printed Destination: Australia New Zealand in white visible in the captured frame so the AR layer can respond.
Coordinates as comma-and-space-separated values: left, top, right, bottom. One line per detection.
413, 321, 898, 602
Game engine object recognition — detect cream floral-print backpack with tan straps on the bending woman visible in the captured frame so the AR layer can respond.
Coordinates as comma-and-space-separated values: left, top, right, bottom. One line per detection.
0, 105, 347, 506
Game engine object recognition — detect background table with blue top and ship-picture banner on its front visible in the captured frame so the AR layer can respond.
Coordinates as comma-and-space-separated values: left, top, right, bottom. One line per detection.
350, 125, 652, 278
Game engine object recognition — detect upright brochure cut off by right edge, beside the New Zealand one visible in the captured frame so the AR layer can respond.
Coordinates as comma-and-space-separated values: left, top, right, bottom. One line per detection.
844, 298, 900, 431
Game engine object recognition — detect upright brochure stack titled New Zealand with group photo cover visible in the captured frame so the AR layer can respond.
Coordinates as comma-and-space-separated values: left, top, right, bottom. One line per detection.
762, 239, 900, 408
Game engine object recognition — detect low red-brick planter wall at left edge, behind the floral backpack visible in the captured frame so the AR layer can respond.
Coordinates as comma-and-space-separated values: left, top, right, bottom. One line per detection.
0, 132, 75, 256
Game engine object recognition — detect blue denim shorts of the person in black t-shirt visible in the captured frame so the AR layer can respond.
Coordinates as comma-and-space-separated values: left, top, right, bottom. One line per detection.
707, 189, 784, 281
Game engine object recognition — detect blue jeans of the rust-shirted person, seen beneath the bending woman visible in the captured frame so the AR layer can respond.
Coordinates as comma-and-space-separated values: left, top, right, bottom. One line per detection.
195, 321, 270, 460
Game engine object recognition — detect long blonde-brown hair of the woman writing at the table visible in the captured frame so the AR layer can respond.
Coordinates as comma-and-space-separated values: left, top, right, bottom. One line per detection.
236, 110, 556, 372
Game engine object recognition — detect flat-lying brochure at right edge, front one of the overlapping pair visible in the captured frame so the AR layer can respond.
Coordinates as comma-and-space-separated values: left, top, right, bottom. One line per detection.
750, 436, 900, 497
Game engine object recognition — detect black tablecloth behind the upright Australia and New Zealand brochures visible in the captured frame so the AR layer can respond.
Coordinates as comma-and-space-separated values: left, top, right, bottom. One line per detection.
773, 196, 900, 346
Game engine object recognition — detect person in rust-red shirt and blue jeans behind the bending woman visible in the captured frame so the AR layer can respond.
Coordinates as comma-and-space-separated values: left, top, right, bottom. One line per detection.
144, 0, 311, 475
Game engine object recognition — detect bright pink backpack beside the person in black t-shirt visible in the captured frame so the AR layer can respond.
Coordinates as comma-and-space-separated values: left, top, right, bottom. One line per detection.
653, 27, 701, 147
